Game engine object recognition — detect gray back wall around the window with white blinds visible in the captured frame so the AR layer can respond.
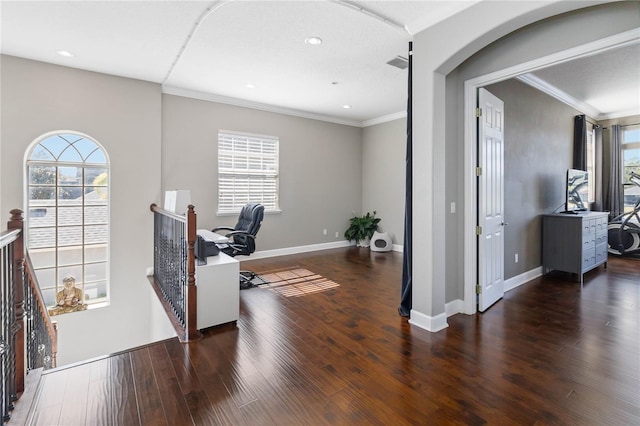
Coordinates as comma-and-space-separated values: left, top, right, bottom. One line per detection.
162, 91, 362, 251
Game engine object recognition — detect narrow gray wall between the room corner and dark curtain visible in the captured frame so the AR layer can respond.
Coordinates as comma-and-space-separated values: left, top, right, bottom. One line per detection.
362, 118, 407, 245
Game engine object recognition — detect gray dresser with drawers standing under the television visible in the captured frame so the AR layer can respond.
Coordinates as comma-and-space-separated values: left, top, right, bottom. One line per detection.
542, 212, 609, 286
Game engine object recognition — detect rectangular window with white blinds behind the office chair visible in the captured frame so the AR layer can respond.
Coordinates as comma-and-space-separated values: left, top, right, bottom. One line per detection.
218, 131, 279, 213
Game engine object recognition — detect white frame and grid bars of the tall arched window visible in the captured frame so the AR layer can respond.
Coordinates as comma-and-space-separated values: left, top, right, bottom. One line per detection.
23, 130, 111, 309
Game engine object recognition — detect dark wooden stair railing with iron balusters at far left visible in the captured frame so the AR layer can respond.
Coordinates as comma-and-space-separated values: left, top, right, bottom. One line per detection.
0, 209, 57, 422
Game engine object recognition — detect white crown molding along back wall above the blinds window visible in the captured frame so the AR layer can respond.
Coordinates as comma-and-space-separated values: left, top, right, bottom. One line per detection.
162, 85, 362, 127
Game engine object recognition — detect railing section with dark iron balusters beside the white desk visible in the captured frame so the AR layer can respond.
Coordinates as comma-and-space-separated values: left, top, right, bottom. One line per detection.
149, 204, 202, 342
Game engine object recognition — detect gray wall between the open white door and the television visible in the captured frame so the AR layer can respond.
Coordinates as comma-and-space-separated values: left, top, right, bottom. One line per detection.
486, 79, 581, 279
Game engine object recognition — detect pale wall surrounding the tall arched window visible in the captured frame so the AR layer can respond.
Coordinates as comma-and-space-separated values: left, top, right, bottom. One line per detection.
0, 56, 172, 365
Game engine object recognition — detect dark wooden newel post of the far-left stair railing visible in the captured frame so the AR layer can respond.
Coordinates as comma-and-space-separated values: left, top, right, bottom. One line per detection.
7, 209, 25, 398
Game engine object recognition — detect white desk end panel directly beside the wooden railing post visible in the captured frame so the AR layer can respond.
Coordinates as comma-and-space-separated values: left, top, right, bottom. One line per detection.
196, 252, 240, 330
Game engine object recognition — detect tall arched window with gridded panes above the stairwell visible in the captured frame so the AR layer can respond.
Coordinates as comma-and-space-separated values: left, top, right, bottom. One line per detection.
25, 132, 109, 307
